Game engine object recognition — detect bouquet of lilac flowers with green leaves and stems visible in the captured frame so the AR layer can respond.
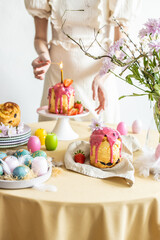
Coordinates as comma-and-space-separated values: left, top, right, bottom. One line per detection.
99, 18, 160, 141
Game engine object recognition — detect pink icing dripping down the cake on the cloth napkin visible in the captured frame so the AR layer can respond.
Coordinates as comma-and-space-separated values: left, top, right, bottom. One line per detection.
90, 127, 122, 163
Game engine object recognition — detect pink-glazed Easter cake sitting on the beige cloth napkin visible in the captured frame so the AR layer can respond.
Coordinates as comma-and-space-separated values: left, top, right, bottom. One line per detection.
90, 127, 122, 168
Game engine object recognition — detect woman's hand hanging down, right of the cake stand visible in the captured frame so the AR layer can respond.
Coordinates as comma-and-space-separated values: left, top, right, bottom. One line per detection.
92, 74, 106, 114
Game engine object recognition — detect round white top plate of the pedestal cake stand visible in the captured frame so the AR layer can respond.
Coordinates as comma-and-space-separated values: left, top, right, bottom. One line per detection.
37, 106, 89, 118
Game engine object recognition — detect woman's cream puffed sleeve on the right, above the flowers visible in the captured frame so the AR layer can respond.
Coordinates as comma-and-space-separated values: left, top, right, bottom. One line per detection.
109, 0, 142, 26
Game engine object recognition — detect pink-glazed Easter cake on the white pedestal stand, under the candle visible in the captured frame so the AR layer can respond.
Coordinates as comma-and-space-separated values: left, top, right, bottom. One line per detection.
48, 79, 75, 115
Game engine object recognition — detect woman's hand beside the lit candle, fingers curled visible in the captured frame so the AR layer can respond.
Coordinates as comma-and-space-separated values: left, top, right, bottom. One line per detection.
32, 53, 51, 80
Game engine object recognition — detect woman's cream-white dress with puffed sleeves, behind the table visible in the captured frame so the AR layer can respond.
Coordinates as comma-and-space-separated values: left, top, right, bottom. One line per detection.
25, 0, 139, 123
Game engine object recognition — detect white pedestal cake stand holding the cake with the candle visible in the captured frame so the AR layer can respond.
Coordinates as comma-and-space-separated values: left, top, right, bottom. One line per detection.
37, 106, 89, 140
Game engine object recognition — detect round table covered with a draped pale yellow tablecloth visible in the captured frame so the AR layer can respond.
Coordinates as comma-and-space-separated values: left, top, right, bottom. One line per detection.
0, 121, 160, 240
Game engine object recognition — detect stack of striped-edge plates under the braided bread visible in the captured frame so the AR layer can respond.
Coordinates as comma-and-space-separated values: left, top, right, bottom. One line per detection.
0, 124, 31, 148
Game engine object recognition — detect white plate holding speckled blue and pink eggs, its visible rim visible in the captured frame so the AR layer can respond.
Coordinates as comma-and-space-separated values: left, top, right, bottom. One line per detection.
0, 164, 52, 189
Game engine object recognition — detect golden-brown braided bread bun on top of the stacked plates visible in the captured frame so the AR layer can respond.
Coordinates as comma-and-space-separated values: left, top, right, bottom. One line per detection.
0, 102, 21, 127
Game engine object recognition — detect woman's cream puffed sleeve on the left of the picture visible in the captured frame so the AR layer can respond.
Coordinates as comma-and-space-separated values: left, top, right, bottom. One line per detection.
24, 0, 51, 19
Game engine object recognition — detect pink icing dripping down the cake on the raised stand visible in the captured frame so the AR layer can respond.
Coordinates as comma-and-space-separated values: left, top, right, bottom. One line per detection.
48, 83, 75, 114
